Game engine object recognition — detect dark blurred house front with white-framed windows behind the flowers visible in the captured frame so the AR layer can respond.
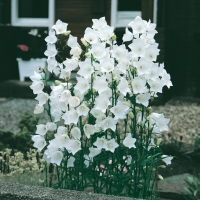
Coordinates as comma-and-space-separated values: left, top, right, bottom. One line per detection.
0, 0, 200, 101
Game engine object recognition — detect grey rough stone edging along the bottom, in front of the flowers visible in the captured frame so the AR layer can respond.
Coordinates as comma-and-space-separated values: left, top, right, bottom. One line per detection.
0, 182, 139, 200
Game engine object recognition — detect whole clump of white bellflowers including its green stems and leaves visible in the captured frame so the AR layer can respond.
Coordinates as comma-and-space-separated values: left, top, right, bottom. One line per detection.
30, 17, 172, 199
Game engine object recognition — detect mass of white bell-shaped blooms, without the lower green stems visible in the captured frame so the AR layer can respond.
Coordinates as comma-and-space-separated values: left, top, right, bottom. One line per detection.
31, 17, 172, 165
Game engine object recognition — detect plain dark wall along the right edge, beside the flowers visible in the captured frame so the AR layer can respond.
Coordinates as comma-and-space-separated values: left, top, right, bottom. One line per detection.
165, 0, 200, 97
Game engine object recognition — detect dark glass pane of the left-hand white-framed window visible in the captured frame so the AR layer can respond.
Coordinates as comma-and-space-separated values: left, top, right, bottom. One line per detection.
18, 0, 49, 18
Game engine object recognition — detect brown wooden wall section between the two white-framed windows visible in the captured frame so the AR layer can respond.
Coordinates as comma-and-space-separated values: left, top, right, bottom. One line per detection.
55, 0, 111, 39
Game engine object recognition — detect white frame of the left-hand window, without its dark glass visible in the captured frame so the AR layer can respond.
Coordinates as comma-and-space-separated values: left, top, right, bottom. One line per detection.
11, 0, 55, 28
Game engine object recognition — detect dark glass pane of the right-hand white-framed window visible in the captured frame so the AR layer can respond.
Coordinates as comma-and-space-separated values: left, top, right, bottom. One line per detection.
118, 0, 142, 11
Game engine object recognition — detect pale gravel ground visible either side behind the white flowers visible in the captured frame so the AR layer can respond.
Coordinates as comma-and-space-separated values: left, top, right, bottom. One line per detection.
0, 98, 200, 143
